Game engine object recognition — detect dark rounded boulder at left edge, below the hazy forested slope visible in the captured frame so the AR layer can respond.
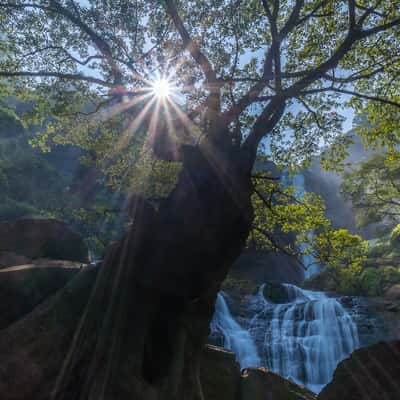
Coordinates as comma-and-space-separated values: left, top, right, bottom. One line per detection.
0, 218, 88, 262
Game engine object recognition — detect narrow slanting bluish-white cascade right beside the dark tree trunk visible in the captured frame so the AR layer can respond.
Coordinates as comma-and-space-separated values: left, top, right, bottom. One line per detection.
210, 293, 261, 369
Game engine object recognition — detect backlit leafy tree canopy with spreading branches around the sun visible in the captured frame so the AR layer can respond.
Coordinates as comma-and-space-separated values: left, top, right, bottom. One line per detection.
0, 0, 400, 177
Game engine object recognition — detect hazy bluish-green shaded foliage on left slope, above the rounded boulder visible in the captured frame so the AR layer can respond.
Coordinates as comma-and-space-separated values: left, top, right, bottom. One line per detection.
0, 100, 127, 256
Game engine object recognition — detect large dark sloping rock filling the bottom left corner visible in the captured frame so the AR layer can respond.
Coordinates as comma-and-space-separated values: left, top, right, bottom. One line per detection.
0, 268, 98, 400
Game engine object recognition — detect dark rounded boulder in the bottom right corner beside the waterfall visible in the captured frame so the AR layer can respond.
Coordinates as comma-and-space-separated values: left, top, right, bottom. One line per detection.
318, 341, 400, 400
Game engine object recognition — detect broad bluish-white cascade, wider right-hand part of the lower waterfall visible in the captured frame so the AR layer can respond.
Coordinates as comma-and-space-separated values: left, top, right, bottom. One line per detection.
250, 284, 359, 392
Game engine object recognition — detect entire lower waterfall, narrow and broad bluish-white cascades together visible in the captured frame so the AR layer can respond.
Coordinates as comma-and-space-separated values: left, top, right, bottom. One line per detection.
210, 284, 360, 393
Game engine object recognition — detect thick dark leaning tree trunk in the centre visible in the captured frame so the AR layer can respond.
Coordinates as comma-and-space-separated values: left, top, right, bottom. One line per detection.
0, 141, 252, 400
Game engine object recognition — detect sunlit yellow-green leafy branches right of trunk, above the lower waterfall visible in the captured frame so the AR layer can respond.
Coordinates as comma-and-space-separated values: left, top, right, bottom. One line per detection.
249, 173, 368, 286
